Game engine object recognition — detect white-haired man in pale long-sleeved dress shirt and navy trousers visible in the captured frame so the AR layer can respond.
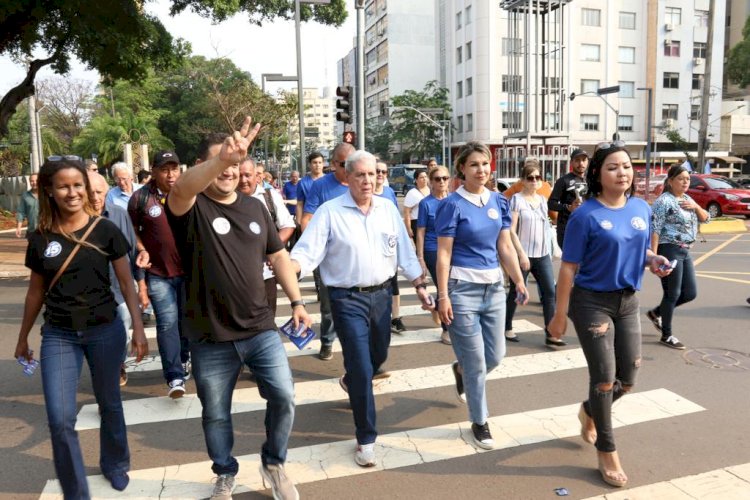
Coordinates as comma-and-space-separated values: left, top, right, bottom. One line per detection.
290, 151, 433, 467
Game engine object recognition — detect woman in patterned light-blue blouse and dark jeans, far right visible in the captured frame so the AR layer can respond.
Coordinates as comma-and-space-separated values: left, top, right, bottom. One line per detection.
646, 165, 709, 349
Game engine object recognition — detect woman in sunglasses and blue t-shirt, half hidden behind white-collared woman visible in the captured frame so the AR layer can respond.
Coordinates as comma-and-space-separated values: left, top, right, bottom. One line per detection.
417, 167, 451, 345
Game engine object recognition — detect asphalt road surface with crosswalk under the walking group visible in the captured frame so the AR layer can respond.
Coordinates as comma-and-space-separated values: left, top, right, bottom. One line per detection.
0, 229, 750, 499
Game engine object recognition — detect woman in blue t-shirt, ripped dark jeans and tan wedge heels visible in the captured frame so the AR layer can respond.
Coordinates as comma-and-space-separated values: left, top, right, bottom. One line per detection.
547, 141, 669, 486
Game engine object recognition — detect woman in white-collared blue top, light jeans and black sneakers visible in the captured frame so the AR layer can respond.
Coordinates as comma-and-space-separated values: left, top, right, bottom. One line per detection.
435, 142, 527, 449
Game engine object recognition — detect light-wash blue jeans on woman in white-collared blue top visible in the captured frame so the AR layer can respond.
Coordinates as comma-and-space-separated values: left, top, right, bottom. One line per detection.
448, 278, 505, 424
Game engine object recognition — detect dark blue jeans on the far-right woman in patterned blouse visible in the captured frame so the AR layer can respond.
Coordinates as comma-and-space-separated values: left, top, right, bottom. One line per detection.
655, 243, 698, 337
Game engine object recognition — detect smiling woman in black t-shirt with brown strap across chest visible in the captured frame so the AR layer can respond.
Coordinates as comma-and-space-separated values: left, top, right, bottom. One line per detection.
15, 156, 148, 499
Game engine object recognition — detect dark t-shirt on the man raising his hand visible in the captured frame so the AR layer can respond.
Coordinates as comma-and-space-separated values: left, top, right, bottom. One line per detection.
165, 193, 284, 342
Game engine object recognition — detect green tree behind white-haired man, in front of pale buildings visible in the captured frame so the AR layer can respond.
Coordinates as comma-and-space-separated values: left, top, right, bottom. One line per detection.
391, 80, 451, 161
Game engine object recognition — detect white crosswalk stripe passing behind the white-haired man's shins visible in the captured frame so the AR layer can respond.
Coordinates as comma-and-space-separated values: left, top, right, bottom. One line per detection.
76, 349, 586, 431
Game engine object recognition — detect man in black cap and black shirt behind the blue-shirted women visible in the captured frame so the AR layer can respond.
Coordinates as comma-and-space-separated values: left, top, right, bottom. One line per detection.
547, 148, 589, 248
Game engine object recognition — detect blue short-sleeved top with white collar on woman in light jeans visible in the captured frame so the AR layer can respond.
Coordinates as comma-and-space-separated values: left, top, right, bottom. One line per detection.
435, 191, 511, 270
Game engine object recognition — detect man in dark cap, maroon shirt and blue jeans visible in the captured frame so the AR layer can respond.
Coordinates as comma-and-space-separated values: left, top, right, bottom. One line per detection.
128, 151, 190, 399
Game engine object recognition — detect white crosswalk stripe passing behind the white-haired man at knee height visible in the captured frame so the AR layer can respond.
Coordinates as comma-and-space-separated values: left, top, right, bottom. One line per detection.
125, 319, 543, 373
